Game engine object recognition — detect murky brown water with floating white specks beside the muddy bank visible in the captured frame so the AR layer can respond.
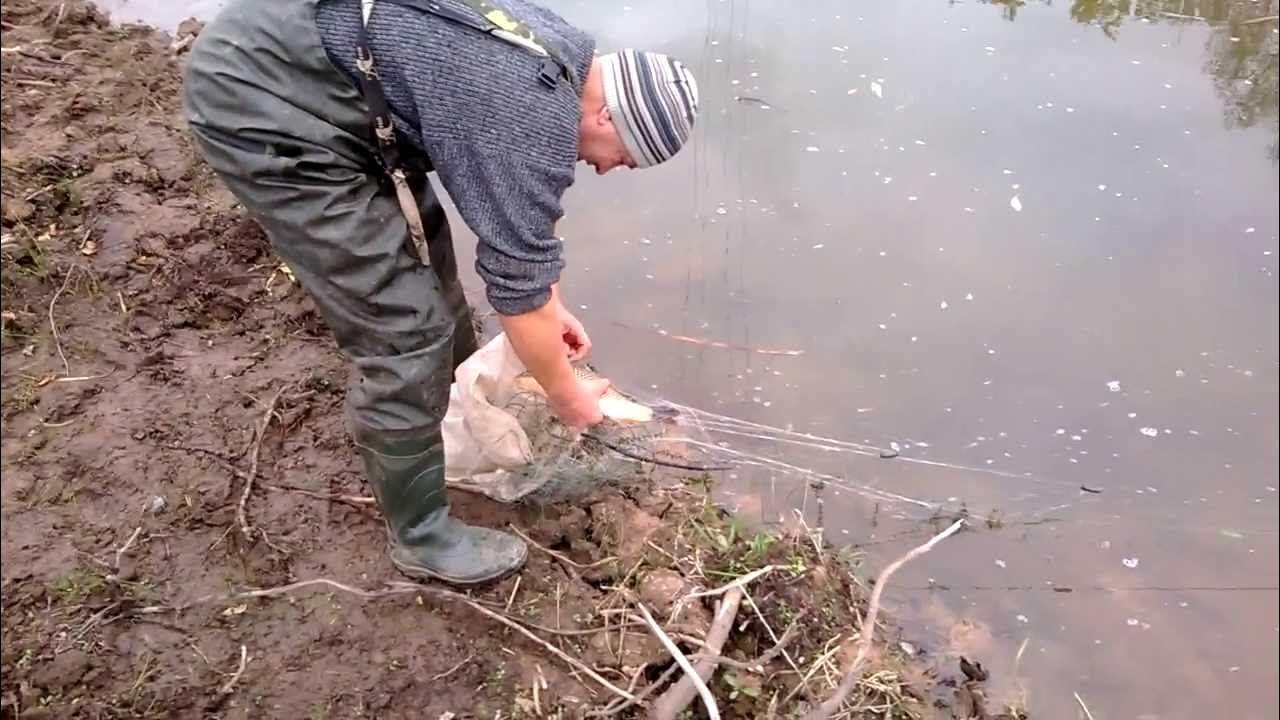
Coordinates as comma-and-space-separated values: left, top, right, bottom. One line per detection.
115, 0, 1280, 720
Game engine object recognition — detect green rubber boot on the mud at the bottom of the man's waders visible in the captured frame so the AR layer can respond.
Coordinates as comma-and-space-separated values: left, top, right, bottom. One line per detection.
353, 427, 529, 585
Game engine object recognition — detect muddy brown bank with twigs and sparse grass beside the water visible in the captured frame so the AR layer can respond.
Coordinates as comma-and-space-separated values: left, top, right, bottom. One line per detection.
0, 0, 1018, 720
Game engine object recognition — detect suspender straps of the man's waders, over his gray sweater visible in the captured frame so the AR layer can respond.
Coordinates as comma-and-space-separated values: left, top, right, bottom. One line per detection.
356, 0, 575, 265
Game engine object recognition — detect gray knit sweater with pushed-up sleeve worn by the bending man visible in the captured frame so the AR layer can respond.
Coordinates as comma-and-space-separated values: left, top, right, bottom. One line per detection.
316, 0, 595, 315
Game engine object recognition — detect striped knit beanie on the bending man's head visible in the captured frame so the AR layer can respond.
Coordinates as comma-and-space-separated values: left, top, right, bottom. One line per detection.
599, 49, 698, 168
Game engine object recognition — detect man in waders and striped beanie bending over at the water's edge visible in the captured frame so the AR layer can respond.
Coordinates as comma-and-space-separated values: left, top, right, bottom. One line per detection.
184, 0, 698, 584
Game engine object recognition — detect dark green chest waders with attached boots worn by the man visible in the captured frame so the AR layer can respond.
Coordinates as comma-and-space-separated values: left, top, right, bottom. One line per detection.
183, 0, 567, 584
